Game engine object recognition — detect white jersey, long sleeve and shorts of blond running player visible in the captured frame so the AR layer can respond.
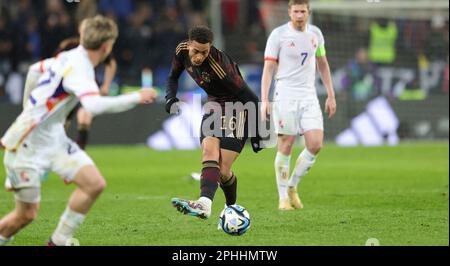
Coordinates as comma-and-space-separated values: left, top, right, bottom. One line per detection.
0, 46, 141, 191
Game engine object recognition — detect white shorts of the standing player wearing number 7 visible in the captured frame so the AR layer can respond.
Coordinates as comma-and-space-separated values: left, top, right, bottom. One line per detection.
272, 100, 323, 136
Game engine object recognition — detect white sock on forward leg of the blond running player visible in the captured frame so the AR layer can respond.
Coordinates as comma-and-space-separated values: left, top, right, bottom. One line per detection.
52, 207, 86, 246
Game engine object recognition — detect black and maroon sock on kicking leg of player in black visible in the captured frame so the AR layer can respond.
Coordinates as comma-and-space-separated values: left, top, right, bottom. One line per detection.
200, 161, 220, 200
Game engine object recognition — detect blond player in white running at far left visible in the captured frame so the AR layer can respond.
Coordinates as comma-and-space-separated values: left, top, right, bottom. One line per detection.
0, 16, 156, 246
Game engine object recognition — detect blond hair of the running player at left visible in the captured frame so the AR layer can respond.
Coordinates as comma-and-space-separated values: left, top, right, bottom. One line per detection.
80, 15, 119, 50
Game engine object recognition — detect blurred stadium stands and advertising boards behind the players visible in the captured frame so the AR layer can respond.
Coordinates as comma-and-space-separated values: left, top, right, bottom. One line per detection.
0, 0, 449, 148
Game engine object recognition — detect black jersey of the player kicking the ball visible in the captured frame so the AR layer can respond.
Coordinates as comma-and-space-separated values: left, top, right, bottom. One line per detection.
166, 39, 259, 110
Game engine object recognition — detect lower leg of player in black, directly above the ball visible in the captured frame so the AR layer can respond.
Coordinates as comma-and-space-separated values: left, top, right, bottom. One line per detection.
220, 149, 239, 206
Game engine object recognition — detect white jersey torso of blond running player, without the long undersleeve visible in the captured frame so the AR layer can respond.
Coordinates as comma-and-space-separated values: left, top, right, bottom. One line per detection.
1, 46, 99, 151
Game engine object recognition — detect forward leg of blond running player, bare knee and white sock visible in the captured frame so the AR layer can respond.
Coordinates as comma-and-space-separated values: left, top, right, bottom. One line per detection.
50, 165, 106, 246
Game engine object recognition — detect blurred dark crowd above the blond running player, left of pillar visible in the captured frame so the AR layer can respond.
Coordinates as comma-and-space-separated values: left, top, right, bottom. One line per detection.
0, 0, 207, 85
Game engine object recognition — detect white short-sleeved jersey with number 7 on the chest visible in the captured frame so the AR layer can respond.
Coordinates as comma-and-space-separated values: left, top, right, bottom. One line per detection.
264, 22, 325, 101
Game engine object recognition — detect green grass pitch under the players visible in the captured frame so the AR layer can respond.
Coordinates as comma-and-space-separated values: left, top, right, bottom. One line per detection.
0, 142, 449, 246
